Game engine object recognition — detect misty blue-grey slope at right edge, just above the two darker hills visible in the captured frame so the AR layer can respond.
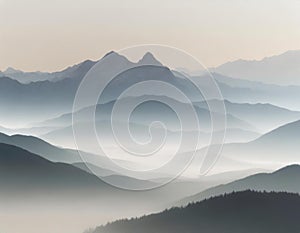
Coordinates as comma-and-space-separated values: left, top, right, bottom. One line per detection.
183, 121, 300, 173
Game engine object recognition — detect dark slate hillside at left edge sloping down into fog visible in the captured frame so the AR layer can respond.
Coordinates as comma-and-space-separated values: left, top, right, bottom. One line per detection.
0, 143, 111, 194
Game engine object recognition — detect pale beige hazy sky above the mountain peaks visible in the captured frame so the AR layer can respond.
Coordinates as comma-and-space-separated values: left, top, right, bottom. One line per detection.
0, 0, 300, 71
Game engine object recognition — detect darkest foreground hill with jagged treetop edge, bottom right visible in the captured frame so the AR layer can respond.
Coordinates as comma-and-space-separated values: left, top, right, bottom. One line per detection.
93, 191, 300, 233
